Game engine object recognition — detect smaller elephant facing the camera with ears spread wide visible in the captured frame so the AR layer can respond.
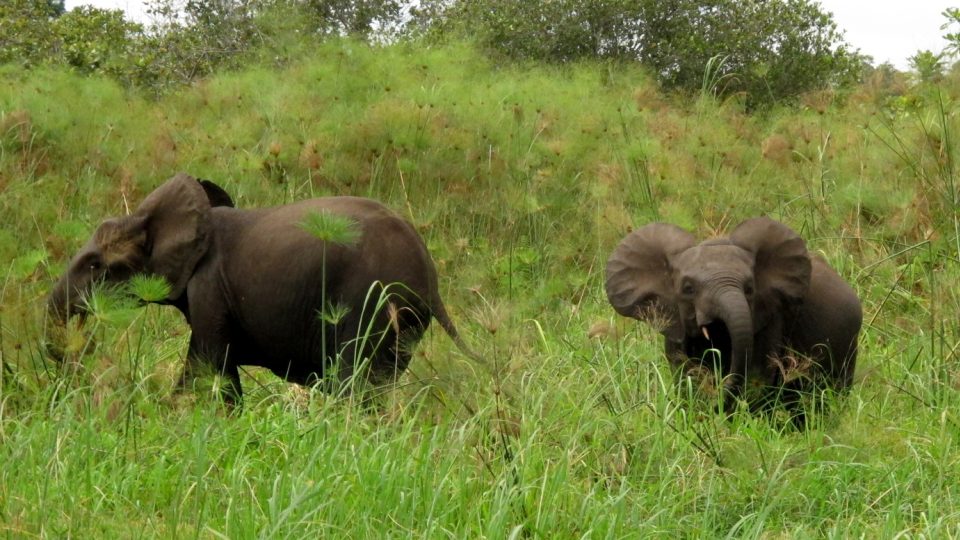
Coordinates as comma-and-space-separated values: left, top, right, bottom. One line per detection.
606, 217, 862, 419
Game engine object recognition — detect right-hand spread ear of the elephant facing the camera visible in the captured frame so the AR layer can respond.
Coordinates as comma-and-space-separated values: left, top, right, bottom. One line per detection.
730, 217, 811, 310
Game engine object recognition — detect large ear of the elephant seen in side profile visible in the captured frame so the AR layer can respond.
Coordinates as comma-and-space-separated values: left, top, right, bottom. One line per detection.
136, 173, 210, 300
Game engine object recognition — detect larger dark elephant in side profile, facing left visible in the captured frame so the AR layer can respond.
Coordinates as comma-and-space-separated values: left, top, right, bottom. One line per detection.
48, 174, 476, 403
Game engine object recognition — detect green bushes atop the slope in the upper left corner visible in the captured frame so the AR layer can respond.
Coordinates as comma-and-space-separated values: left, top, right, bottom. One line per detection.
0, 0, 405, 93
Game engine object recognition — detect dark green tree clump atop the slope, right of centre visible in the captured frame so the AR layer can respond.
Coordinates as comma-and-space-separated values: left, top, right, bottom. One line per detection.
413, 0, 863, 107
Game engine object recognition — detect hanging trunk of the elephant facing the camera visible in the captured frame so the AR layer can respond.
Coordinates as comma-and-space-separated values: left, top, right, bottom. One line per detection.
717, 288, 753, 404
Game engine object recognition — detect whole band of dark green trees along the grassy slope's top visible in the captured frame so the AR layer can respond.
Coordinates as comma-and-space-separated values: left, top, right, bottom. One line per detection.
0, 0, 868, 107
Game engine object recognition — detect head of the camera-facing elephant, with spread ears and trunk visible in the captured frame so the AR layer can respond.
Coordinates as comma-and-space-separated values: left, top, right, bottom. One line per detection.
606, 217, 811, 394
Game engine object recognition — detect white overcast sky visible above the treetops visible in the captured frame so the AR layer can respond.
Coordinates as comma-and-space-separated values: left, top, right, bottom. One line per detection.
66, 0, 960, 69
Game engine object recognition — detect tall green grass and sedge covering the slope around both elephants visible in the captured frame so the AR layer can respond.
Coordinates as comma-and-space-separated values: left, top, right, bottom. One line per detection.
0, 2, 960, 538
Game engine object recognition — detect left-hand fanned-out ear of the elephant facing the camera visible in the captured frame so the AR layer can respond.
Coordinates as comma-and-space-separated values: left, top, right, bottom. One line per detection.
606, 223, 696, 333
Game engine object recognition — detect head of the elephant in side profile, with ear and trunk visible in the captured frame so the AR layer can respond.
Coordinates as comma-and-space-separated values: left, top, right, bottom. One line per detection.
47, 173, 233, 358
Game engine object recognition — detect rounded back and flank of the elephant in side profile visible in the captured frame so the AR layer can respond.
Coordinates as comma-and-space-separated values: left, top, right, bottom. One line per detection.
220, 197, 437, 371
